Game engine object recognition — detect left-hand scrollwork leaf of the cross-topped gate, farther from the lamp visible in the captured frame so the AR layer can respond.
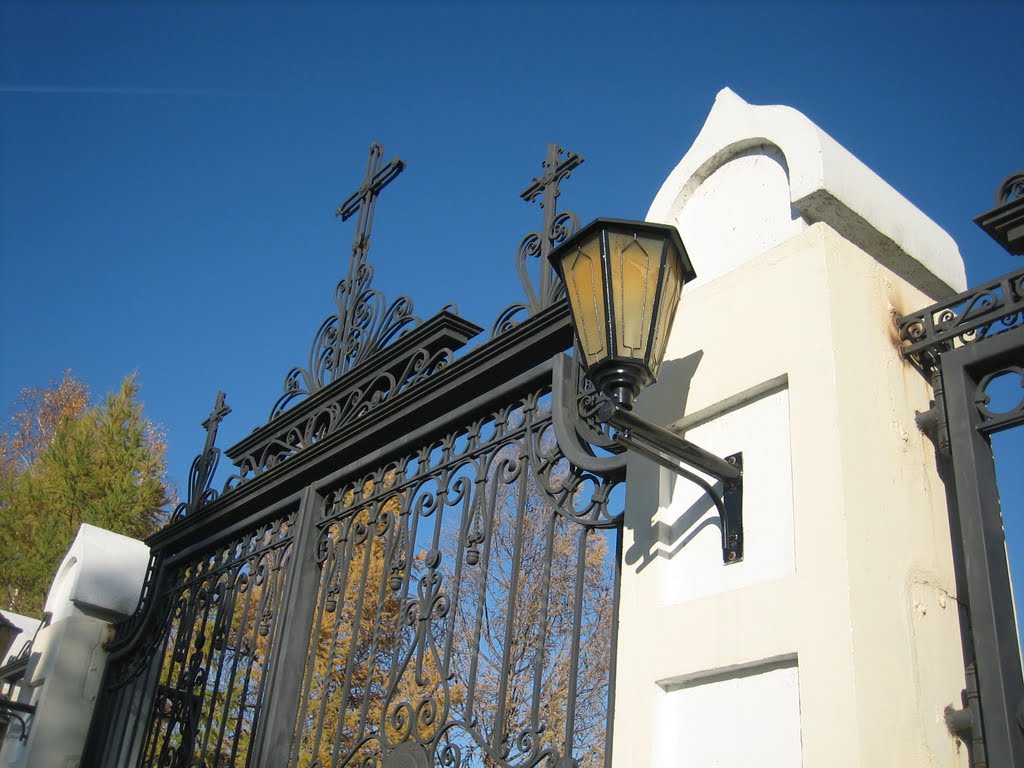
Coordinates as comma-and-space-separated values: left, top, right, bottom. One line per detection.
144, 515, 294, 766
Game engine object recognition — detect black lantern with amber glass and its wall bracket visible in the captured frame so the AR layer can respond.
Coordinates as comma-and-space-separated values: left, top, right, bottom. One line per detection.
548, 218, 743, 563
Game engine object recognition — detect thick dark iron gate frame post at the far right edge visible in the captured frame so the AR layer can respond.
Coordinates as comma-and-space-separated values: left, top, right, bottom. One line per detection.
940, 334, 1024, 768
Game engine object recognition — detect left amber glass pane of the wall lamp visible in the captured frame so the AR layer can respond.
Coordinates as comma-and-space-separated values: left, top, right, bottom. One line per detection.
562, 232, 608, 368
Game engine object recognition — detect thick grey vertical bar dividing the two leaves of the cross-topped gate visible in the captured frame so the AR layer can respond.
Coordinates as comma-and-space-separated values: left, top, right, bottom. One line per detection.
249, 486, 324, 766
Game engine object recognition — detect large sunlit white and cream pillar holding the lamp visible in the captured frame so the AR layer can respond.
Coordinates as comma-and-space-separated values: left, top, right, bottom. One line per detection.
613, 90, 967, 768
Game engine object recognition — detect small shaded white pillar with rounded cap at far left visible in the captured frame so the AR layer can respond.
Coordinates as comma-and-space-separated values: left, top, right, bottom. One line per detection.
0, 525, 150, 768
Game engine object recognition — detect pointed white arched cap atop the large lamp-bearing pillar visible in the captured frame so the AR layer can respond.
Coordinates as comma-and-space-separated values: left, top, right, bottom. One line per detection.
647, 88, 967, 298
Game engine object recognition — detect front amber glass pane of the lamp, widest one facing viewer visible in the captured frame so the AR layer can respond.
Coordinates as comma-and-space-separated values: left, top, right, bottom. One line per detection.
608, 231, 662, 359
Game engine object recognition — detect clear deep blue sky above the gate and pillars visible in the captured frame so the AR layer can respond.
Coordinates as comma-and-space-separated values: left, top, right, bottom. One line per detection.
0, 0, 1024, 614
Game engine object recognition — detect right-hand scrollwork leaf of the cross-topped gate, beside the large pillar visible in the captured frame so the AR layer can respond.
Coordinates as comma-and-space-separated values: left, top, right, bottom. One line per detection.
293, 387, 623, 768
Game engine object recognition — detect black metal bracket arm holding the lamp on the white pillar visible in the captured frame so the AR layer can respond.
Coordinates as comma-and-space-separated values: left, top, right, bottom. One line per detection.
597, 400, 743, 565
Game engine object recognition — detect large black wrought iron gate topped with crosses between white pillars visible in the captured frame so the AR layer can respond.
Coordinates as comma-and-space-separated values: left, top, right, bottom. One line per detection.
85, 144, 625, 768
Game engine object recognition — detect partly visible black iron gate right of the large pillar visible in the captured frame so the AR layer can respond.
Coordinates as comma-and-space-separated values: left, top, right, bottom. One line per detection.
900, 173, 1024, 768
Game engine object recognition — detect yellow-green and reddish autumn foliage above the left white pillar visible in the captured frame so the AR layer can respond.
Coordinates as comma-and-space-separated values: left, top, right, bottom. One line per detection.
0, 372, 170, 614
